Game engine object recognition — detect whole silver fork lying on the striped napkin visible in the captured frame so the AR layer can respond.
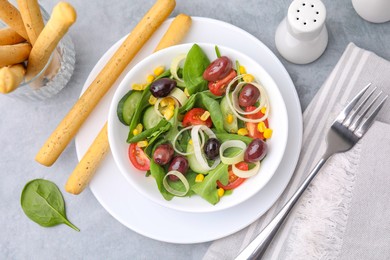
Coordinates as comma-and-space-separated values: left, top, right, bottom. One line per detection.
236, 83, 388, 259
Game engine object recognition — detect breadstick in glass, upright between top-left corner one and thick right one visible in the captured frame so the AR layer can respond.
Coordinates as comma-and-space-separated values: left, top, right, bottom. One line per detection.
18, 0, 45, 46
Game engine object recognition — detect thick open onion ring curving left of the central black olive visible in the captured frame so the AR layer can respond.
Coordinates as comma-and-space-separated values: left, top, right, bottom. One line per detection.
191, 125, 221, 172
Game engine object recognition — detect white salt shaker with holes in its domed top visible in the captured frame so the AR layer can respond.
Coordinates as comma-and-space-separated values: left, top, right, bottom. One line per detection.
275, 0, 328, 64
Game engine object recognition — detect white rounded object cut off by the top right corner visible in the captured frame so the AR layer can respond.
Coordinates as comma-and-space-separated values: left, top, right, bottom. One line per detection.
352, 0, 390, 23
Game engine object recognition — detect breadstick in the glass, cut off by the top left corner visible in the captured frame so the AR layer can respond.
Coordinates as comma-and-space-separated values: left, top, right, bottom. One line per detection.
0, 0, 29, 41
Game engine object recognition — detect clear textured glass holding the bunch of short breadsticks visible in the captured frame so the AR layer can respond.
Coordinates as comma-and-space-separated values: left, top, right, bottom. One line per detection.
0, 4, 76, 100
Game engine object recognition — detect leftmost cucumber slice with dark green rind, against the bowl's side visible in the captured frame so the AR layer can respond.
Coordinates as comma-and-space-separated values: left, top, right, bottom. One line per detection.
116, 90, 142, 125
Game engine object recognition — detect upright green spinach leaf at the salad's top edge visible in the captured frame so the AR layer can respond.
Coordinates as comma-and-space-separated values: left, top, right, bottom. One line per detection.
183, 44, 210, 95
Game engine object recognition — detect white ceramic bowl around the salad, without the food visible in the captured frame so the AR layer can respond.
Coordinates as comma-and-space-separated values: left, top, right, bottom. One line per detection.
108, 43, 288, 212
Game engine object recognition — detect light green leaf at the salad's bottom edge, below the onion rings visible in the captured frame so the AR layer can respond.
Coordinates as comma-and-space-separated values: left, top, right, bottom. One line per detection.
192, 163, 229, 205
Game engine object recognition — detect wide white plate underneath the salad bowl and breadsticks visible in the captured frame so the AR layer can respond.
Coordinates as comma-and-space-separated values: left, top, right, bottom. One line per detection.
76, 17, 302, 244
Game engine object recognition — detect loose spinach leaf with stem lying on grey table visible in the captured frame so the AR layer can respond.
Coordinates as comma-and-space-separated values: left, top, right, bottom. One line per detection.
20, 179, 80, 231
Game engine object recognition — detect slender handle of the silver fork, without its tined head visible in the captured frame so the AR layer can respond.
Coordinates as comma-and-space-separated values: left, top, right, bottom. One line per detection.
236, 155, 329, 260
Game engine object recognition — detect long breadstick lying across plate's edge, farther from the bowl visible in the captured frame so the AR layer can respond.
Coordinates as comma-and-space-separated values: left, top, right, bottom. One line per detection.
35, 0, 176, 166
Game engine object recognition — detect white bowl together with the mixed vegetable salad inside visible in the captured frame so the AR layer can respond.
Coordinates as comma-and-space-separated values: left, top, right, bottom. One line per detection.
108, 44, 288, 212
